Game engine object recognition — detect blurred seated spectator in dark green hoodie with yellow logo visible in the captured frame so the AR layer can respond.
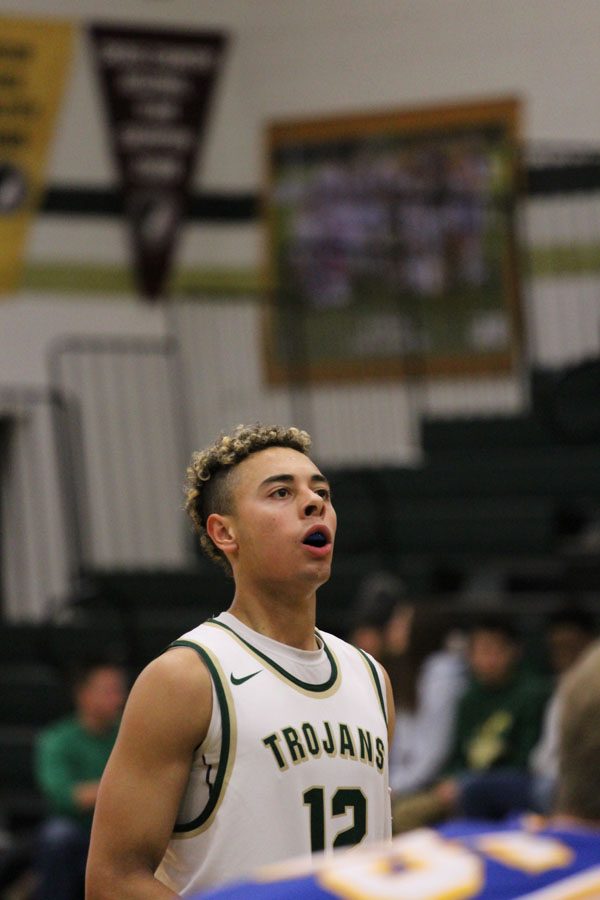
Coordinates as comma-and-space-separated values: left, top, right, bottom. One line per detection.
393, 618, 548, 831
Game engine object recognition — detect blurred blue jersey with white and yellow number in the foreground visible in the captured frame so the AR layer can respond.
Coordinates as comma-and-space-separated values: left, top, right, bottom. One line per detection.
202, 819, 600, 900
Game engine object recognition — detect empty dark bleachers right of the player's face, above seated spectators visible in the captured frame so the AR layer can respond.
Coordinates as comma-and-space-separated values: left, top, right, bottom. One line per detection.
328, 361, 600, 594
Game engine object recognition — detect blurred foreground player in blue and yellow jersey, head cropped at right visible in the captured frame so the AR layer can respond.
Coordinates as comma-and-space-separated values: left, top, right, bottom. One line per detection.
198, 643, 600, 900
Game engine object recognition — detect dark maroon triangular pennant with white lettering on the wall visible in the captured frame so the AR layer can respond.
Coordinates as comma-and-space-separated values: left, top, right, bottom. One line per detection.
90, 25, 226, 300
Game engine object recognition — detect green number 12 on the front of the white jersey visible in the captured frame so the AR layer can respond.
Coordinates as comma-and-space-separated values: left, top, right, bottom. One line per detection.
302, 787, 367, 853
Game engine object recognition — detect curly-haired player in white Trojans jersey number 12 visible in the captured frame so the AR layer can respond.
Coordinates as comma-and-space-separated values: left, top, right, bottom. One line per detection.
86, 425, 394, 900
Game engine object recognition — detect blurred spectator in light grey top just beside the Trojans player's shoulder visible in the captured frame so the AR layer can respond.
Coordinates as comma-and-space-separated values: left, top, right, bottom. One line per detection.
382, 604, 466, 796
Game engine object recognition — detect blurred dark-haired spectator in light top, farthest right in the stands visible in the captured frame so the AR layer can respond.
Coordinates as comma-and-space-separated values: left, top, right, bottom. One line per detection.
529, 606, 596, 813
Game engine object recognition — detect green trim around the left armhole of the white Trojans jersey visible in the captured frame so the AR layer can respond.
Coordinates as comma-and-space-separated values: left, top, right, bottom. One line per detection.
169, 640, 235, 837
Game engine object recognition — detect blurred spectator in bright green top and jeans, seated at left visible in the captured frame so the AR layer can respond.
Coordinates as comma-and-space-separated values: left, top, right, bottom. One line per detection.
34, 660, 126, 900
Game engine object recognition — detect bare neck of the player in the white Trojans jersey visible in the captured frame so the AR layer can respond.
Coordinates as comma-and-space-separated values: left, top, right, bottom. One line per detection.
228, 586, 317, 650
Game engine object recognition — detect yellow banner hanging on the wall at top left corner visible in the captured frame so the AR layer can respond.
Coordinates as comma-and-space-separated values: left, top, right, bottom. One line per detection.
0, 18, 74, 293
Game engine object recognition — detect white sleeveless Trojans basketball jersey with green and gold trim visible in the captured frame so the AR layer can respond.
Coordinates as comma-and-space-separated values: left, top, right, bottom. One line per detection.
156, 613, 391, 896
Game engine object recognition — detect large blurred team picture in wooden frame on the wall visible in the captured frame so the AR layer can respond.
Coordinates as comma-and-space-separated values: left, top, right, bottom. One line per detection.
266, 98, 520, 383
